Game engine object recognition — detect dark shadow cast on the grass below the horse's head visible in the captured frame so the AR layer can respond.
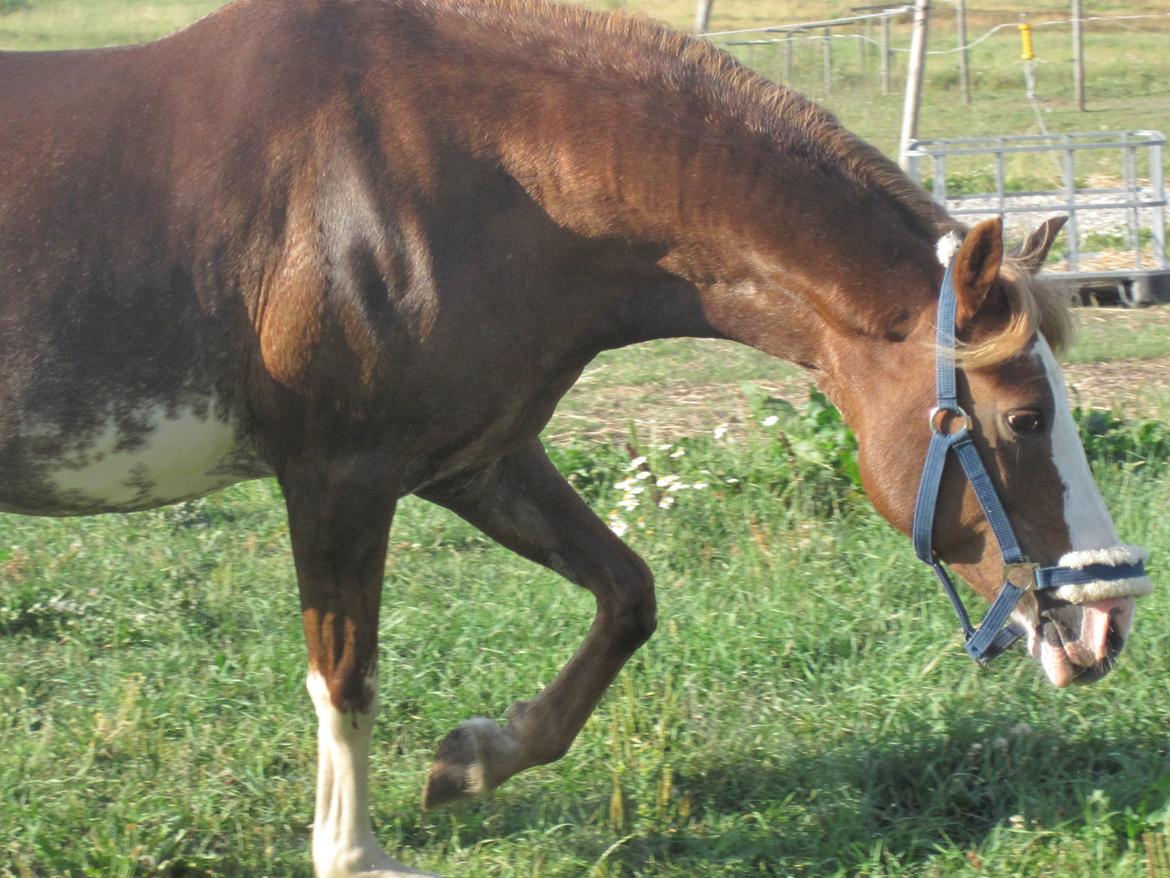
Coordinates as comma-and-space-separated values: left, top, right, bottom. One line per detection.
406, 715, 1170, 874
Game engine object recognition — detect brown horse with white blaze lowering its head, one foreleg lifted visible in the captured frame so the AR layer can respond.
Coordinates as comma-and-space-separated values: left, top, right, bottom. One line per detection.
0, 0, 1148, 878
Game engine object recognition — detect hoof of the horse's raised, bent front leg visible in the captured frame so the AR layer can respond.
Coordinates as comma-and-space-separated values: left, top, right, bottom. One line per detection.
422, 716, 524, 808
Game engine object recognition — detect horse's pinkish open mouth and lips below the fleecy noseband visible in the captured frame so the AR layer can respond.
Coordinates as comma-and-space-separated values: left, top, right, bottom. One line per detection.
1027, 597, 1134, 688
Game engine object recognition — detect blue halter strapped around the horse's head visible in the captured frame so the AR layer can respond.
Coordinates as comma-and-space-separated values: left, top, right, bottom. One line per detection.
913, 258, 1145, 665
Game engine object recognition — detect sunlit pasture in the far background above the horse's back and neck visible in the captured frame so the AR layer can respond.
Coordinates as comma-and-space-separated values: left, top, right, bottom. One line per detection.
0, 0, 1170, 181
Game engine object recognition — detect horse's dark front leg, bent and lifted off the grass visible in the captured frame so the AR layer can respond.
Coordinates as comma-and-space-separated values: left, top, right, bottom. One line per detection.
422, 441, 656, 808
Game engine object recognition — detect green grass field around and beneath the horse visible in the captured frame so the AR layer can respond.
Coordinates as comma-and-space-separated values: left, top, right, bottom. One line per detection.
0, 0, 1170, 878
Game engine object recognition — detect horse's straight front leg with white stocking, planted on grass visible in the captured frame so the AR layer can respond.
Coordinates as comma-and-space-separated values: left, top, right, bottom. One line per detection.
281, 460, 435, 878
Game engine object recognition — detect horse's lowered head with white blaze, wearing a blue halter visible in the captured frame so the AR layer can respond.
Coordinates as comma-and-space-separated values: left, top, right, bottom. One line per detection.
849, 219, 1151, 686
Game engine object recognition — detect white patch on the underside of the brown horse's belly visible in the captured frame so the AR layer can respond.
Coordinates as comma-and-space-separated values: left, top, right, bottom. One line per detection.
0, 405, 269, 515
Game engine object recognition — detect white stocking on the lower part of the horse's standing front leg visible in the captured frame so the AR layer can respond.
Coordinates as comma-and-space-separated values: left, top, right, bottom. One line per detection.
305, 672, 435, 878
